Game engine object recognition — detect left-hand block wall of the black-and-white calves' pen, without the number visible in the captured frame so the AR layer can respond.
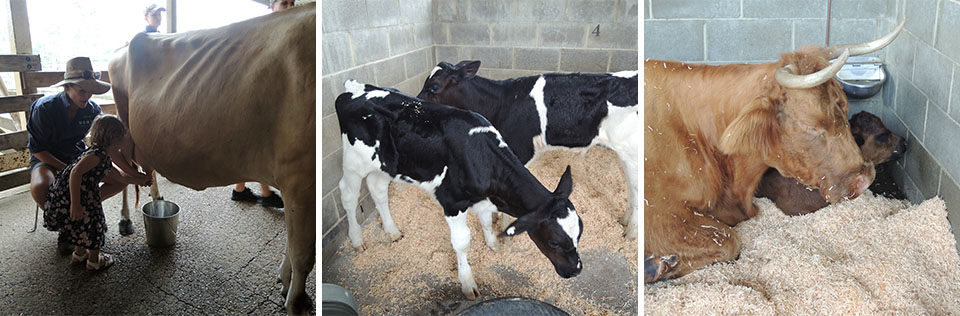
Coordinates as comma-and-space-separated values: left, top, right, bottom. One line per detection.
320, 0, 435, 260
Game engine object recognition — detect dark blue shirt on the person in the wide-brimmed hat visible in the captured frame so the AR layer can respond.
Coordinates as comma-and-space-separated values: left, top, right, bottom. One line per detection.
27, 92, 102, 165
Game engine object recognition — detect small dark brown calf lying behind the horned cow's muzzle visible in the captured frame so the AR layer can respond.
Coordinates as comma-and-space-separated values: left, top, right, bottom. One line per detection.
757, 112, 906, 216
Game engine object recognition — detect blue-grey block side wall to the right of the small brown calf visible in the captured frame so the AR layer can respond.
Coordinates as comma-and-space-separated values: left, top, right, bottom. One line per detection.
881, 0, 960, 246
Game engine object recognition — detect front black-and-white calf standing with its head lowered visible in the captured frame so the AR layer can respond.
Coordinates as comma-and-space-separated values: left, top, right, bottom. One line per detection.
336, 80, 583, 299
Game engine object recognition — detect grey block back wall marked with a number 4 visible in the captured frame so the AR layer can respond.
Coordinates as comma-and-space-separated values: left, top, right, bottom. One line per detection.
434, 0, 639, 79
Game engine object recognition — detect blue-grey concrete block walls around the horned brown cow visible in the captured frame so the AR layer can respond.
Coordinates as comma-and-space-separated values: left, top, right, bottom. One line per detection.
643, 0, 960, 252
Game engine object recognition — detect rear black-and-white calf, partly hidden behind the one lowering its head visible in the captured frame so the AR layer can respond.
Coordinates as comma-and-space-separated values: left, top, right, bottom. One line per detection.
417, 61, 641, 239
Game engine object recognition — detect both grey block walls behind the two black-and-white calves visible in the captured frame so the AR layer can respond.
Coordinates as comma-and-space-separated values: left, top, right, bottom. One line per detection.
321, 0, 639, 261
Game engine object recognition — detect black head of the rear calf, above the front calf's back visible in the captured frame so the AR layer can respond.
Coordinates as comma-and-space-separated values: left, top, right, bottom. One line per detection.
417, 60, 480, 108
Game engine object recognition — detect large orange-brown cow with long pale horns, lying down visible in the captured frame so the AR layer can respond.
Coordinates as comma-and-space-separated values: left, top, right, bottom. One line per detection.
643, 22, 903, 282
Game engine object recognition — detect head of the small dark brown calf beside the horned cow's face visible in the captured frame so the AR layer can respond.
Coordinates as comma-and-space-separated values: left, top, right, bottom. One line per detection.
850, 112, 907, 165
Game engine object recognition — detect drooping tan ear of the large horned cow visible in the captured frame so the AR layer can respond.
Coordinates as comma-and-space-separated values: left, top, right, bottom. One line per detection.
719, 99, 780, 155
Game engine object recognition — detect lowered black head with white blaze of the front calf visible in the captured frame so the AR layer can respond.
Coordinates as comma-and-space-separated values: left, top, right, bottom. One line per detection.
500, 166, 583, 278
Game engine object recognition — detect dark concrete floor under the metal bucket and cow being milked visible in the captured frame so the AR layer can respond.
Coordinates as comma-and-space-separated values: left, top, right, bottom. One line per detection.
0, 178, 317, 315
